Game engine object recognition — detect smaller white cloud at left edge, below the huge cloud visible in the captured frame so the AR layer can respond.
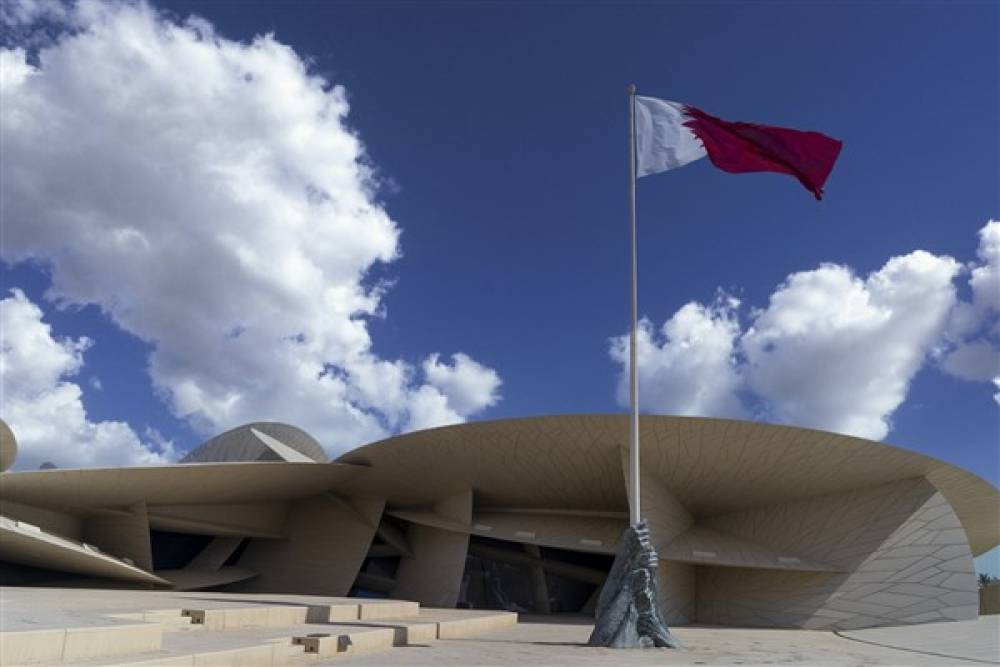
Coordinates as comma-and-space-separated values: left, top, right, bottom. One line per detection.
0, 290, 173, 470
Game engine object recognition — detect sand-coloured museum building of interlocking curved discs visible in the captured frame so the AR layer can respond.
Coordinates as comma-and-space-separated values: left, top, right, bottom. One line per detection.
0, 415, 1000, 629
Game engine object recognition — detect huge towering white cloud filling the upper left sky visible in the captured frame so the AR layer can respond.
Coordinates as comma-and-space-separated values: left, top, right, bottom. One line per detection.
0, 1, 499, 460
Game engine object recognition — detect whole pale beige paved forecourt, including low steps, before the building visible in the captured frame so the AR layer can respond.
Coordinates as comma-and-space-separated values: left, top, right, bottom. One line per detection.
0, 588, 1000, 667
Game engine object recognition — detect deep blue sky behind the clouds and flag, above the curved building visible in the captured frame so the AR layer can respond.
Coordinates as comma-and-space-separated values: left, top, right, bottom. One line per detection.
2, 2, 1000, 569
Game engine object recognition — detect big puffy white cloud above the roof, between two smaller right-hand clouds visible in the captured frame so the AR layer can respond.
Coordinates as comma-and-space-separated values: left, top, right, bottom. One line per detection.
741, 251, 960, 439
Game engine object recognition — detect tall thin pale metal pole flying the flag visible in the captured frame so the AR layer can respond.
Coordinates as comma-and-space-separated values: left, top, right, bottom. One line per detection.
628, 83, 642, 526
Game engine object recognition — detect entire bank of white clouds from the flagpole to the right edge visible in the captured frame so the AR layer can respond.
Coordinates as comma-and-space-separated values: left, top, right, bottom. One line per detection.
610, 227, 1000, 439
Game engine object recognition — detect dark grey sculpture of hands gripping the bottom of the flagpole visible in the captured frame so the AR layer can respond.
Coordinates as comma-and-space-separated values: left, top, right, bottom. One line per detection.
587, 521, 680, 648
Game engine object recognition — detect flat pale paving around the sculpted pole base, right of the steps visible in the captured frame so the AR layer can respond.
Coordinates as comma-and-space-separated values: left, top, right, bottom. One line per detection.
330, 616, 1000, 667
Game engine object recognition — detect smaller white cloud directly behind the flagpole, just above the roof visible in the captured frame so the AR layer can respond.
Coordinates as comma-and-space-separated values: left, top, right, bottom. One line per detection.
611, 295, 744, 418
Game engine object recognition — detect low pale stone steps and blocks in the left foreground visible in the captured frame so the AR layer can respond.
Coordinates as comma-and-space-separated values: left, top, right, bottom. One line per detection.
0, 603, 517, 667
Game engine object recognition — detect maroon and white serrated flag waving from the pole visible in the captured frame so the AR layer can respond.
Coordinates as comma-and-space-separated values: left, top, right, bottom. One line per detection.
635, 95, 842, 199
